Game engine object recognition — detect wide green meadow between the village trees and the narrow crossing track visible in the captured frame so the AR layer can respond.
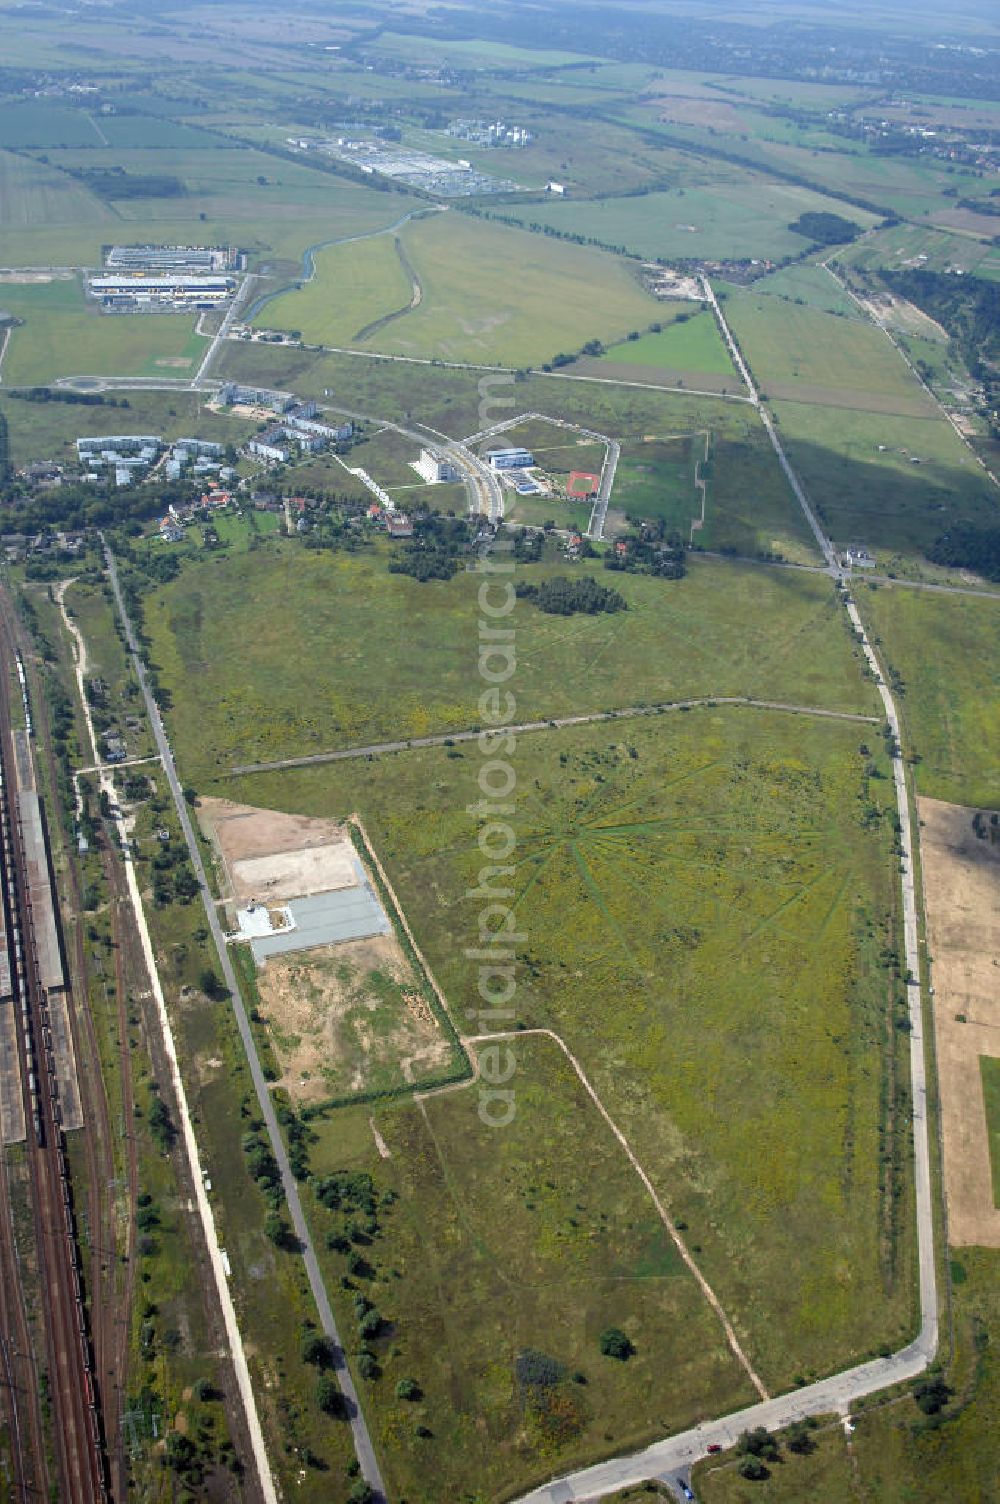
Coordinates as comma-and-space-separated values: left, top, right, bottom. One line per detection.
144, 543, 874, 787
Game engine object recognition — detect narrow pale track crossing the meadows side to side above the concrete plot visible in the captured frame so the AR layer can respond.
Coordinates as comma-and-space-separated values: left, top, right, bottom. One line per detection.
221, 695, 880, 778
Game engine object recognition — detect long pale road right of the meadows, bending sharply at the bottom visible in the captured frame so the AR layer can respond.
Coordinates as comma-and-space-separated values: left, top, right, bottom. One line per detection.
517, 280, 938, 1504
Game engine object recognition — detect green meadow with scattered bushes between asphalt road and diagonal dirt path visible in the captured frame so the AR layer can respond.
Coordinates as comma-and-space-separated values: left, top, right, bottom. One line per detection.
294, 1038, 752, 1504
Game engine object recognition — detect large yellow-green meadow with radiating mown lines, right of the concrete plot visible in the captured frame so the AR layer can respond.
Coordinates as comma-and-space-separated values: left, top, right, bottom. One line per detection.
230, 707, 911, 1390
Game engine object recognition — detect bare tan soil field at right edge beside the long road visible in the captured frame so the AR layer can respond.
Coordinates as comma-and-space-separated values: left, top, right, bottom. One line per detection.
917, 799, 1000, 1248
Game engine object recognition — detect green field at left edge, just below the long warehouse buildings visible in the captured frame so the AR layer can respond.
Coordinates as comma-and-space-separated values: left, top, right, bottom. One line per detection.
0, 277, 209, 387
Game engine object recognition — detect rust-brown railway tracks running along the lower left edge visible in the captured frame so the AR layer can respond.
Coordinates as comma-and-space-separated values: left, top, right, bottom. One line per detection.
0, 644, 110, 1504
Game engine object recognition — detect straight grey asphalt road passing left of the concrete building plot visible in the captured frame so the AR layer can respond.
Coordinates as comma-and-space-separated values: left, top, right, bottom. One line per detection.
102, 540, 385, 1504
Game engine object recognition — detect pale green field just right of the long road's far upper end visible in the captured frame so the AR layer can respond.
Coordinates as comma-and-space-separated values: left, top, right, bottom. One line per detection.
725, 292, 937, 418
